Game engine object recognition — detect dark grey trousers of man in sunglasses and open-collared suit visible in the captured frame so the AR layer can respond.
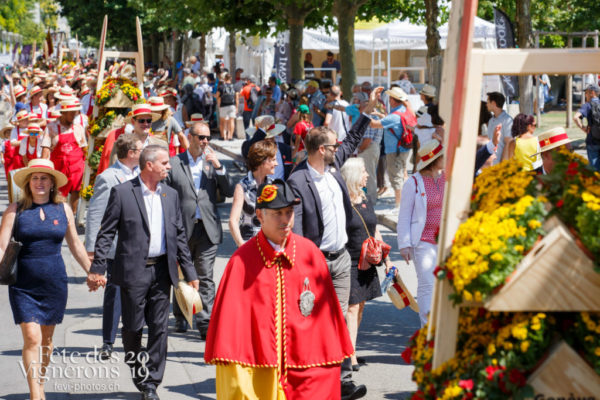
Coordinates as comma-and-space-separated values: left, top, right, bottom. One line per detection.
173, 221, 218, 334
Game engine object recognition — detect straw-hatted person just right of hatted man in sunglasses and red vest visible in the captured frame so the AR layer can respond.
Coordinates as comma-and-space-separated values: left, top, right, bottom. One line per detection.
148, 96, 190, 157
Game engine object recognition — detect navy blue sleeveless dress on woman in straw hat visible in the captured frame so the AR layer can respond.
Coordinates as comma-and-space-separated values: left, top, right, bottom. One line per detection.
8, 203, 68, 325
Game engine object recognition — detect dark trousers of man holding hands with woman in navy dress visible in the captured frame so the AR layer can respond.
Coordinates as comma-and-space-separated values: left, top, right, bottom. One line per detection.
121, 257, 171, 391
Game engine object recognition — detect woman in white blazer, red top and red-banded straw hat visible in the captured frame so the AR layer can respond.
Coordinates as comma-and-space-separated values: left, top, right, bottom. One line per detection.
397, 139, 446, 326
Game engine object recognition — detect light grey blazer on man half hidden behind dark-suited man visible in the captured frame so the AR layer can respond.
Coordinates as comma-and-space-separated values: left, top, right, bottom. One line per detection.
85, 164, 132, 260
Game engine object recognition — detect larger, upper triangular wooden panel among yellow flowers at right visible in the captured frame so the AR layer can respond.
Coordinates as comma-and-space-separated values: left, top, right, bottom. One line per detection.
485, 220, 600, 312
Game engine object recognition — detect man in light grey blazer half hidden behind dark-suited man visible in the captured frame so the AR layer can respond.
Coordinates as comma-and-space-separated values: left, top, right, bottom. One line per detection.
85, 135, 142, 360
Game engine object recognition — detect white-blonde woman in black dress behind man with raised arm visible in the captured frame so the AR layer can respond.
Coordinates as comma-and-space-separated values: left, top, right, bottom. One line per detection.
340, 157, 392, 371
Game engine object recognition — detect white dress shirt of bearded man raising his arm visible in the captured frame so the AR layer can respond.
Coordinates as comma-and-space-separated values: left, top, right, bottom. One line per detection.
307, 163, 348, 251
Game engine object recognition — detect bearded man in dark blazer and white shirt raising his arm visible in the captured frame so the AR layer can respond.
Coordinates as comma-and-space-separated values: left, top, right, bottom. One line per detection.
287, 104, 370, 399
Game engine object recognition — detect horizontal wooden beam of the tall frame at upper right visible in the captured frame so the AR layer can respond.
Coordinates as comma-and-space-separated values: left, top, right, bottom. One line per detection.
476, 49, 600, 75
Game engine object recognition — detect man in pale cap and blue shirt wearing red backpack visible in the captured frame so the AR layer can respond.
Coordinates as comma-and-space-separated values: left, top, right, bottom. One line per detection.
365, 87, 417, 209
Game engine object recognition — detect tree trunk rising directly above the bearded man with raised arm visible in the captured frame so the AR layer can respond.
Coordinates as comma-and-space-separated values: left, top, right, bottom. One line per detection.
333, 0, 359, 100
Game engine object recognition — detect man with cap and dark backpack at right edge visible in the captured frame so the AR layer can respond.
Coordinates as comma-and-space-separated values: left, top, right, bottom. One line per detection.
573, 85, 600, 171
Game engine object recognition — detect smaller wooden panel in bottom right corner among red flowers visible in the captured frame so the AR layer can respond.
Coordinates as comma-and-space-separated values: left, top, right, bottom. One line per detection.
528, 341, 600, 399
